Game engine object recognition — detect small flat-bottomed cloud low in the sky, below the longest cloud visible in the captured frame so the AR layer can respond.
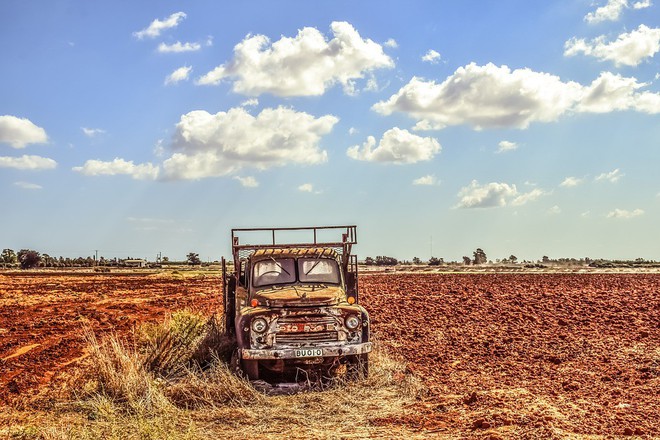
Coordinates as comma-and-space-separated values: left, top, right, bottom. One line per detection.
456, 180, 545, 208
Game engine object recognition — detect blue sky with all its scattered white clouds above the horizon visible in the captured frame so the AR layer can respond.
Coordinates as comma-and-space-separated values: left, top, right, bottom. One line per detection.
0, 0, 660, 260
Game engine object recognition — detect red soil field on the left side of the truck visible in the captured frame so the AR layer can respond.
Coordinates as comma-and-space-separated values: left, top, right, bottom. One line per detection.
0, 272, 222, 407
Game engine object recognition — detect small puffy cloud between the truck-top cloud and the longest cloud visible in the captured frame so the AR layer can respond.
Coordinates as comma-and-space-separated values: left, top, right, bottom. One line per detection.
346, 127, 441, 164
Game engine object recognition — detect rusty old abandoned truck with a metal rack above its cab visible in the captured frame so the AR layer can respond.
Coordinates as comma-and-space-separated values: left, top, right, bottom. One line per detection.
223, 226, 372, 384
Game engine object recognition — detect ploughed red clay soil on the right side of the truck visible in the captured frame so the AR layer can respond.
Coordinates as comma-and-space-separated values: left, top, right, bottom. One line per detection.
360, 274, 660, 438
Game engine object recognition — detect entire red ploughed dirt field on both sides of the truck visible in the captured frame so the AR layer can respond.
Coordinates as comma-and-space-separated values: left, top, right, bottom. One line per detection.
0, 272, 660, 438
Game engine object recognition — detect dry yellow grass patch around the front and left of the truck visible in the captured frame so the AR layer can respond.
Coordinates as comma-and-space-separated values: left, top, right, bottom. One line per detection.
0, 312, 423, 439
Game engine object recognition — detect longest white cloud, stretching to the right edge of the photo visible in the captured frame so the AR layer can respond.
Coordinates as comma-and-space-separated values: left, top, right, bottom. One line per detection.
372, 63, 660, 130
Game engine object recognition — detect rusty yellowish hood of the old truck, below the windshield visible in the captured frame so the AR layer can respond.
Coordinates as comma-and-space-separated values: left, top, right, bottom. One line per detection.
254, 286, 346, 307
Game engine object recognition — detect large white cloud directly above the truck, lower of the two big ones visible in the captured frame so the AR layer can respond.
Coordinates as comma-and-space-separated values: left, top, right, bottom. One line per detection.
163, 107, 338, 179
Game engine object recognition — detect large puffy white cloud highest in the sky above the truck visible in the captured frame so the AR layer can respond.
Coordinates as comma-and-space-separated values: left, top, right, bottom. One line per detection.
197, 22, 394, 96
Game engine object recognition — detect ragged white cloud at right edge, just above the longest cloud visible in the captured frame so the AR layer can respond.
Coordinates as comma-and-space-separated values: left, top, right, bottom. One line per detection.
564, 24, 660, 66
